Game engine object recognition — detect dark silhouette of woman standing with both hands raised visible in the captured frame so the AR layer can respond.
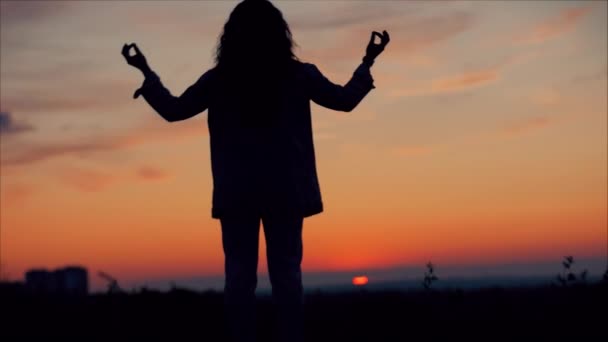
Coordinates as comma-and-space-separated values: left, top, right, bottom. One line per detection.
122, 0, 389, 342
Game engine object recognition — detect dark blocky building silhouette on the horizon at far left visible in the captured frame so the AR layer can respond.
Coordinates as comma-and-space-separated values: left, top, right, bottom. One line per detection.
25, 266, 89, 295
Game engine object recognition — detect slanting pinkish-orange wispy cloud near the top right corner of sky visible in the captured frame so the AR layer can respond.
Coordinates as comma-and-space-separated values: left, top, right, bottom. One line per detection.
514, 6, 592, 44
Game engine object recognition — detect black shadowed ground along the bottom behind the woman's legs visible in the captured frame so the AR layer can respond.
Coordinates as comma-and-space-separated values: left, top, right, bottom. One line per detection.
0, 285, 608, 342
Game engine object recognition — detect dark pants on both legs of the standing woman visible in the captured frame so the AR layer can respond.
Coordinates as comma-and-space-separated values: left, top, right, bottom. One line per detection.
221, 216, 304, 342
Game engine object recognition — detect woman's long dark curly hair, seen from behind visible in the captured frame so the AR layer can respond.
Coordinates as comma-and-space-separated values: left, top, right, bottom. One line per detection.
215, 0, 298, 126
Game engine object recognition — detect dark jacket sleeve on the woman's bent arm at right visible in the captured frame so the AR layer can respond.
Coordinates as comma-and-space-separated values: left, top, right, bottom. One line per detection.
306, 63, 375, 112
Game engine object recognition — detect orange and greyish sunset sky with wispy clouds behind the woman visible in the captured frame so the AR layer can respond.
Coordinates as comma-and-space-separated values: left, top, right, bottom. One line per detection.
0, 0, 608, 288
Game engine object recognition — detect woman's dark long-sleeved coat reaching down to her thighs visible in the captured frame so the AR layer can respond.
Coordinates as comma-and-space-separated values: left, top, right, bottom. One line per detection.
140, 62, 375, 218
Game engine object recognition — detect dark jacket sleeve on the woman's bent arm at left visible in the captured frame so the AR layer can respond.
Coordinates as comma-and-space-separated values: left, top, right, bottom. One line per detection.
135, 71, 211, 122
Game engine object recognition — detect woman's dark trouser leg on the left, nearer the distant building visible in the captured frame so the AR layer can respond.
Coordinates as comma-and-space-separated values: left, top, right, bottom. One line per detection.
221, 216, 260, 342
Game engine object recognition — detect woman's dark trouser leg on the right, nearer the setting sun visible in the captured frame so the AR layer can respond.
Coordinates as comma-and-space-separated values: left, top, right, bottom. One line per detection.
262, 216, 304, 342
